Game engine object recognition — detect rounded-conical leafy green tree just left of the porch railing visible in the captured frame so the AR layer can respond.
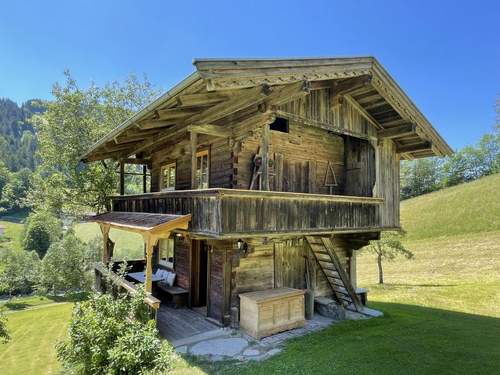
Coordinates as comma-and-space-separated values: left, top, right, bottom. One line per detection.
37, 230, 94, 294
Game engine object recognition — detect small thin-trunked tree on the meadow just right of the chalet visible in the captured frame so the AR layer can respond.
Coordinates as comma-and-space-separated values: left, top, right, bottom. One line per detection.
367, 231, 414, 284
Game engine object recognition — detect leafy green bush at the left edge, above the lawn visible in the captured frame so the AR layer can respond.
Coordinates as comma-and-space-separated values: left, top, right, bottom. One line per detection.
0, 250, 40, 295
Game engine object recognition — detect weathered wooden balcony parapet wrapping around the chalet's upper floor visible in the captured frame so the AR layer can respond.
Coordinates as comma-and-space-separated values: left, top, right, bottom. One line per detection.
111, 188, 384, 238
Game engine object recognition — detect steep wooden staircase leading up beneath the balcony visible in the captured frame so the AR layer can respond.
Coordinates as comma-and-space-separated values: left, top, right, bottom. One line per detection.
306, 236, 363, 312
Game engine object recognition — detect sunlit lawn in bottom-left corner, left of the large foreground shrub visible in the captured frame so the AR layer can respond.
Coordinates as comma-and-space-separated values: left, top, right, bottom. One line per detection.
0, 303, 73, 375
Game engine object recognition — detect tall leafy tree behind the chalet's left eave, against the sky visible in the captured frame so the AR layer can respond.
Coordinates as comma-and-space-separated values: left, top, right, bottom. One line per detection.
30, 72, 156, 215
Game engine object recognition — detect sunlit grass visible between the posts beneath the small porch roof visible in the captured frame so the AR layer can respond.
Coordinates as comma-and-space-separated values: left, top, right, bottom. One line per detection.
75, 223, 144, 259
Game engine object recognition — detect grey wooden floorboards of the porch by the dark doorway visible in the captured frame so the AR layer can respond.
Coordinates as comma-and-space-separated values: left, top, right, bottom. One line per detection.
157, 304, 218, 341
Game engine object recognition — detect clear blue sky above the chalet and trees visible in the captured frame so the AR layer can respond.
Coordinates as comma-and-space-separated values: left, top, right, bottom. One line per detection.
0, 0, 500, 148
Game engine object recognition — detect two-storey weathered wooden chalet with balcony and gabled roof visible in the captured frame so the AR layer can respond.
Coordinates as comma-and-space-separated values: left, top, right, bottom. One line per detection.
82, 57, 452, 340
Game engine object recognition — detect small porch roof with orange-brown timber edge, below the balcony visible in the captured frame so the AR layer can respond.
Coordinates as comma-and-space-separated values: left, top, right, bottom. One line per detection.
91, 211, 191, 234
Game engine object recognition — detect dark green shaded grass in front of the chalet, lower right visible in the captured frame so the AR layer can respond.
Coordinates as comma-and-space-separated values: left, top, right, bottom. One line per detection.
187, 303, 500, 375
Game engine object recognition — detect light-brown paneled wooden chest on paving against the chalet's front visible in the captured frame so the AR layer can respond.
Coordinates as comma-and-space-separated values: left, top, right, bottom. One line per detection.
240, 288, 305, 339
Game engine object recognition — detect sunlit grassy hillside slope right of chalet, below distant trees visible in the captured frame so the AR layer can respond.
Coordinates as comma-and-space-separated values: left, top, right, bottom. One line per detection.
401, 173, 500, 241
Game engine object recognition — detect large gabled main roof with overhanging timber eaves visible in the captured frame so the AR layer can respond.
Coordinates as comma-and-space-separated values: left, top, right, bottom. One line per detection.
81, 57, 453, 161
